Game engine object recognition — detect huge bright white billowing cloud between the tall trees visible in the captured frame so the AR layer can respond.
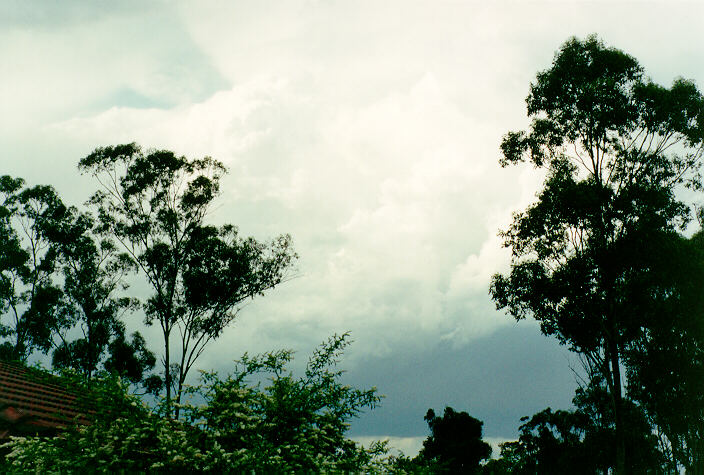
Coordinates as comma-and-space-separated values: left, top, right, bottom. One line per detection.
52, 65, 544, 354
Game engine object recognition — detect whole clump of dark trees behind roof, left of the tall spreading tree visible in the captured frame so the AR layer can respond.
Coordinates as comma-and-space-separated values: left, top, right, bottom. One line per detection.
0, 176, 155, 390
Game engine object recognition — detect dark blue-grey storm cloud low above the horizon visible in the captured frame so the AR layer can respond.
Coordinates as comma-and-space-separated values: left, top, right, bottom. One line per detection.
347, 317, 578, 438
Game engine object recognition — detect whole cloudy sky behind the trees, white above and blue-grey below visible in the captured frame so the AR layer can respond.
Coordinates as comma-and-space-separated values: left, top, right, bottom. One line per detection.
0, 0, 704, 454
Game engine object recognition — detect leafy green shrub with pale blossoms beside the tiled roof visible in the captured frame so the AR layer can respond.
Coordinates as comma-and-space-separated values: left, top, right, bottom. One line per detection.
2, 335, 387, 473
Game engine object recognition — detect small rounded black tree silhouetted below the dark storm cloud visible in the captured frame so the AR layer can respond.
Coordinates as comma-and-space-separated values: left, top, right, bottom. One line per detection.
415, 407, 491, 473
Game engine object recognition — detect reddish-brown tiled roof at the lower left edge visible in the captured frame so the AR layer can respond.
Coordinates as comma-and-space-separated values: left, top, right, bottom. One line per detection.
0, 362, 88, 439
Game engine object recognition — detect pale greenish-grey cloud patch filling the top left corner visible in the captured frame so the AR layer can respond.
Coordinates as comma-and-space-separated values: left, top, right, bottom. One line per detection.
0, 2, 224, 134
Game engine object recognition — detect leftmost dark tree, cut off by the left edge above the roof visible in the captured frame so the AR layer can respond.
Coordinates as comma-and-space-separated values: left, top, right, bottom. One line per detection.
0, 175, 68, 361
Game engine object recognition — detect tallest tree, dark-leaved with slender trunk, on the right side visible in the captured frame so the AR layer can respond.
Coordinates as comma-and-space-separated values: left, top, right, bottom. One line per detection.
490, 36, 704, 473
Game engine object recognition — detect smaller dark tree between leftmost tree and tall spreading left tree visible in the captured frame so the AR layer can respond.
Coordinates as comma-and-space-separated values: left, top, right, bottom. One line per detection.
48, 208, 156, 388
